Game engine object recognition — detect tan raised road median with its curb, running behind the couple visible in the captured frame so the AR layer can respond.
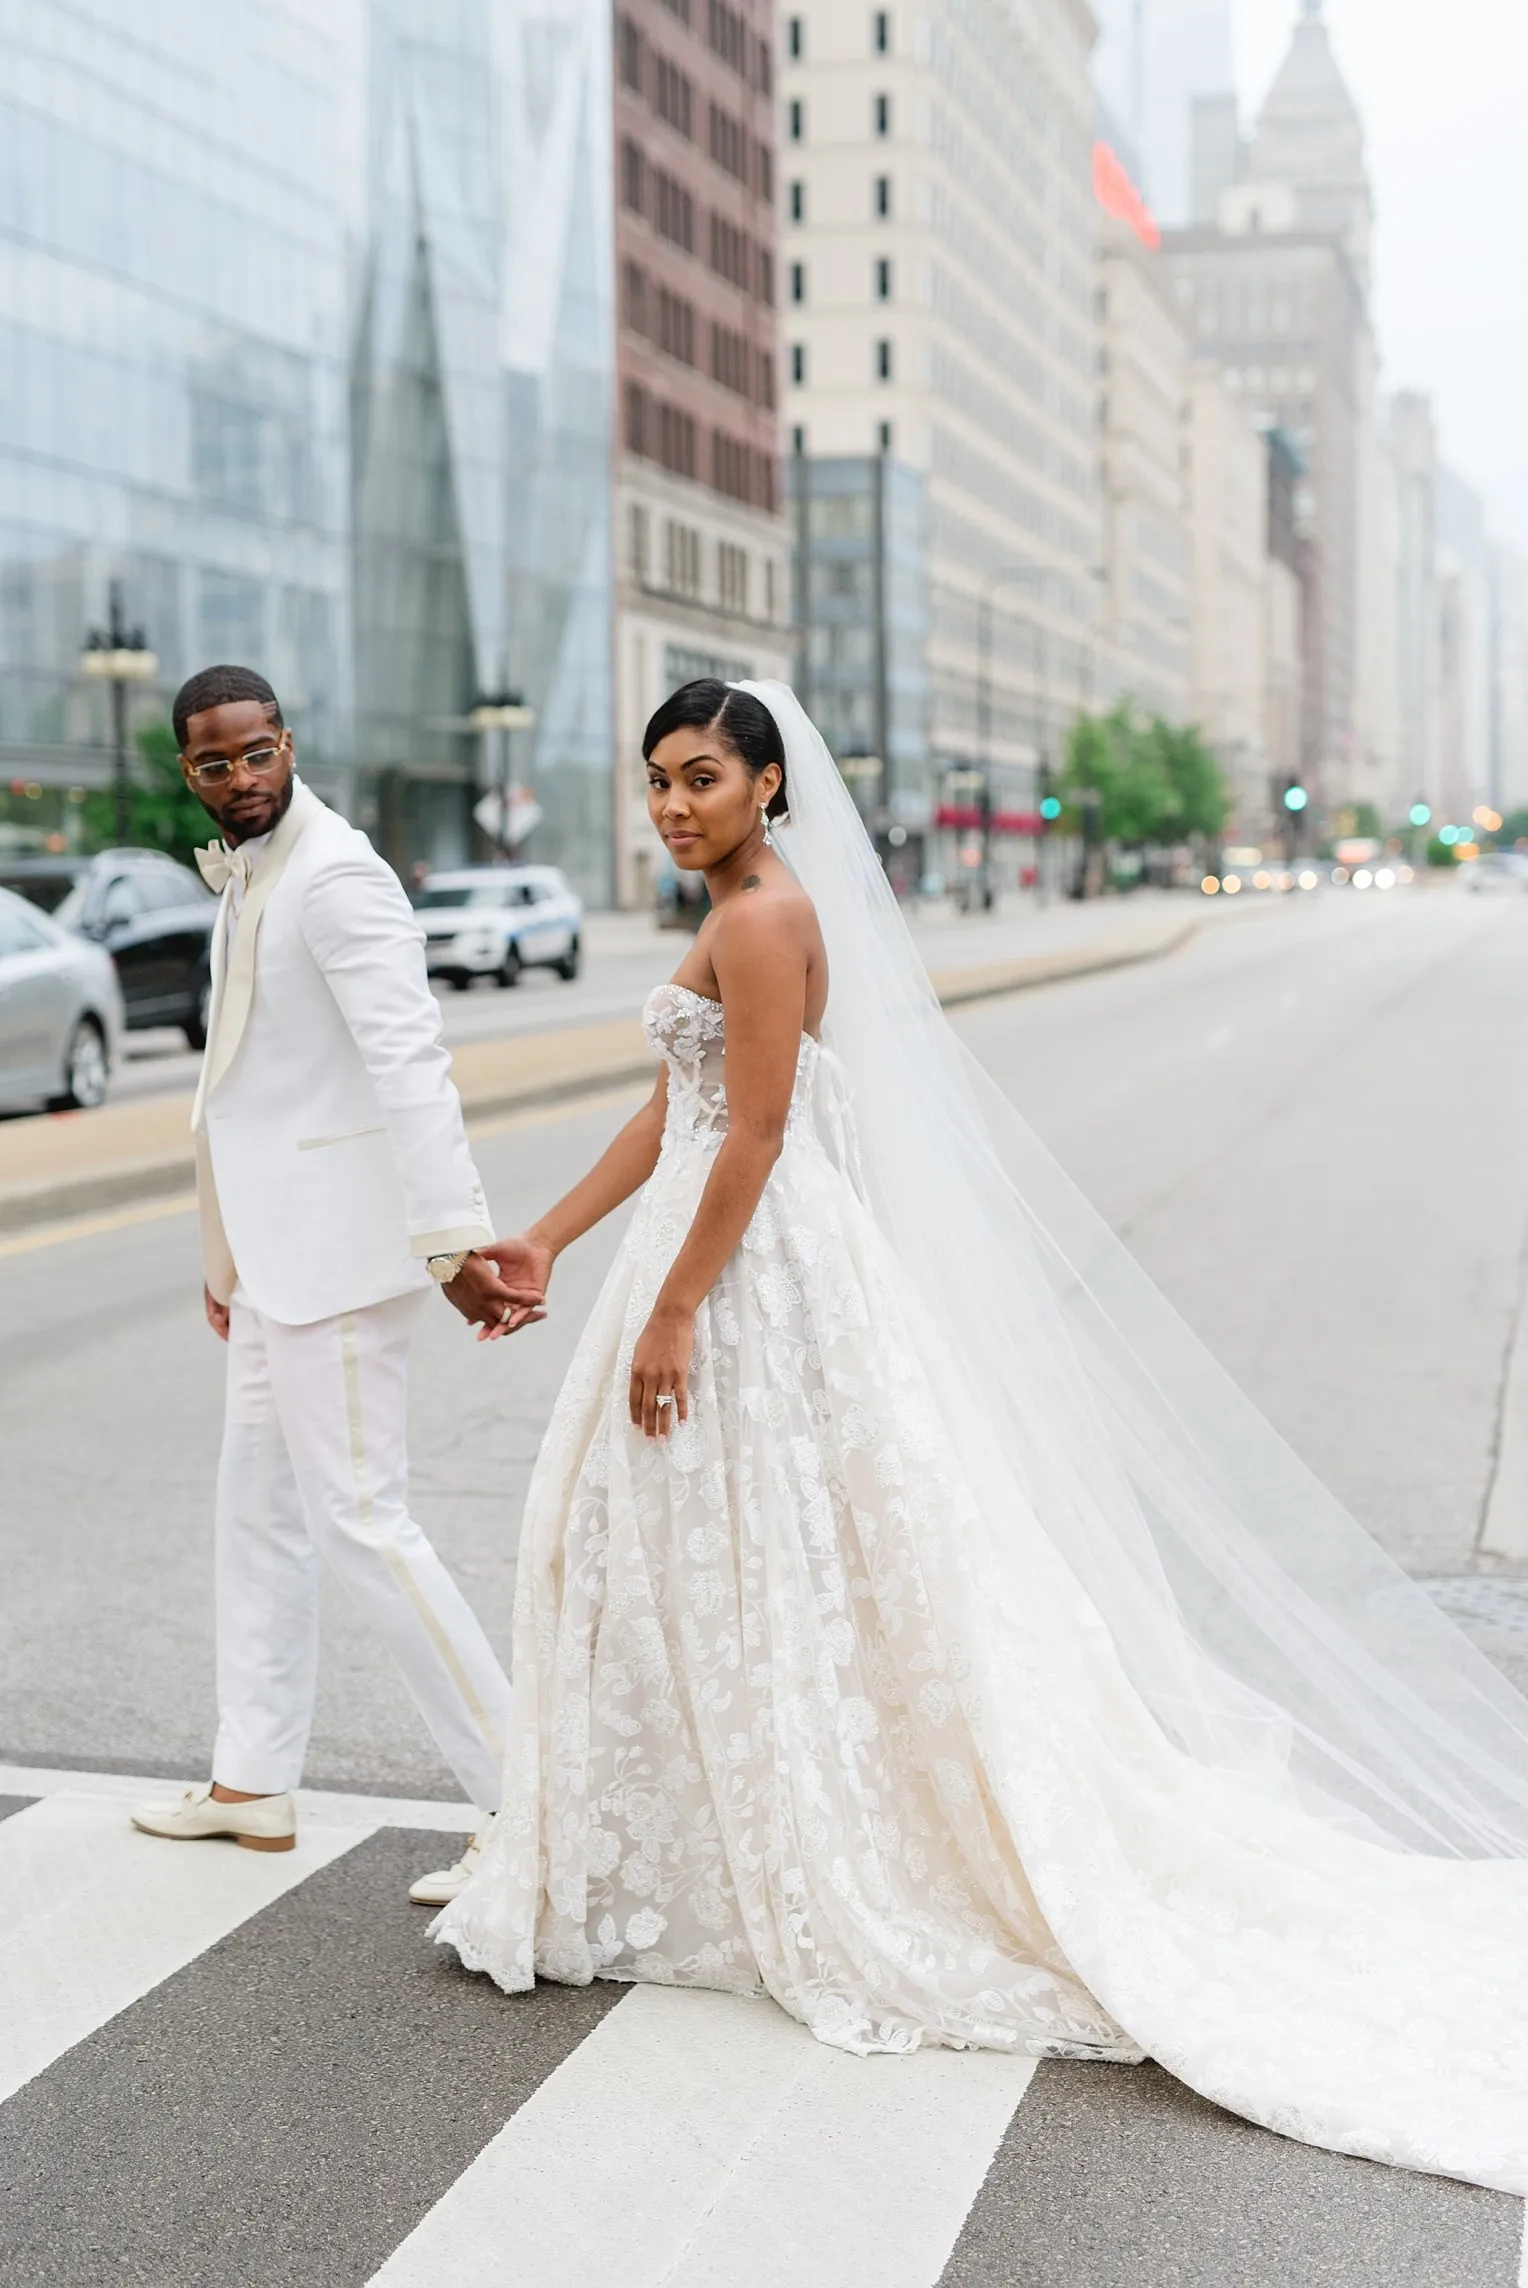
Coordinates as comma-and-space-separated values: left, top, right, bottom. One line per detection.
0, 892, 1219, 1231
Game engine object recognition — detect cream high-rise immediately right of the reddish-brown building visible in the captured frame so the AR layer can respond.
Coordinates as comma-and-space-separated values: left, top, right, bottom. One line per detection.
780, 0, 1100, 876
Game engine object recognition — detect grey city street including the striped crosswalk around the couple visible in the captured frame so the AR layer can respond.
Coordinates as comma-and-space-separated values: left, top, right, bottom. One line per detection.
0, 885, 1528, 2288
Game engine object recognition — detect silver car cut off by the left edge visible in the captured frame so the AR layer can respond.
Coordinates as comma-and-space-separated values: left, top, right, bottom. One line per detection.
0, 890, 121, 1112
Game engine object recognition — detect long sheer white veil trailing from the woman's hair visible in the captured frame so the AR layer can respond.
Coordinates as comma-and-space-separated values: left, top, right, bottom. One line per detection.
739, 682, 1528, 1858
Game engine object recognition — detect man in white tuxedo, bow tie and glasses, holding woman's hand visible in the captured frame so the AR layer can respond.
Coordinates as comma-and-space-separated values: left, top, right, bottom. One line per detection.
133, 668, 540, 1904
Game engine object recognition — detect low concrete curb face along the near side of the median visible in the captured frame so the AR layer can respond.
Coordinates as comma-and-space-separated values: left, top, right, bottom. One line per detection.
0, 920, 1203, 1236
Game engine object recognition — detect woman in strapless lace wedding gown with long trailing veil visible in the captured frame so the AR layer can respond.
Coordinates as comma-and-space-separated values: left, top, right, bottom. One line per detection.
435, 682, 1528, 2194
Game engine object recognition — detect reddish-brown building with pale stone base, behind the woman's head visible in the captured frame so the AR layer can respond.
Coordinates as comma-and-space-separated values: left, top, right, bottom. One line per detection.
615, 0, 789, 901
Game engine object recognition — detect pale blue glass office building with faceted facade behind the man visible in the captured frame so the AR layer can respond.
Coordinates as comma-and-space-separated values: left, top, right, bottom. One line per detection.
0, 0, 613, 899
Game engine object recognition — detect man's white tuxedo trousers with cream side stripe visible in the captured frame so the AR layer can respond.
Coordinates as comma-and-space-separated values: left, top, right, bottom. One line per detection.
213, 1290, 510, 1810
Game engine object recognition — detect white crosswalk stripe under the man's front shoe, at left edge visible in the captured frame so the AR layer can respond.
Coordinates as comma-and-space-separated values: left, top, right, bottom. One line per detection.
0, 1794, 371, 2103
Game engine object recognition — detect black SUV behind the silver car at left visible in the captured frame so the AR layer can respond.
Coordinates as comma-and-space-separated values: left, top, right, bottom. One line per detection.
0, 851, 217, 1048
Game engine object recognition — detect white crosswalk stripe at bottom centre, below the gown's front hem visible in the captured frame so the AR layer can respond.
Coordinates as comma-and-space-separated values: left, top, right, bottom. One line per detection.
373, 1986, 1034, 2288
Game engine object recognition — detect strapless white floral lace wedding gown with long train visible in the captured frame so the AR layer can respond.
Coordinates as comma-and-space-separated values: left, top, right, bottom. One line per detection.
435, 984, 1528, 2192
